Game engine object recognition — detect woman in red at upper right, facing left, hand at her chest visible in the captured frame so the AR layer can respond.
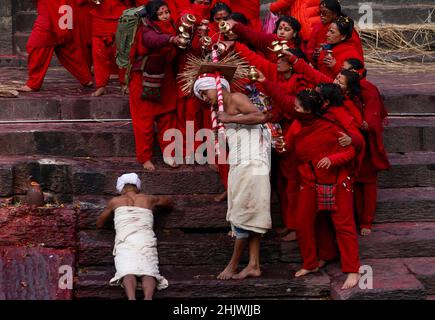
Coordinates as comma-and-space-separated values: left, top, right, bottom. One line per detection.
317, 16, 364, 78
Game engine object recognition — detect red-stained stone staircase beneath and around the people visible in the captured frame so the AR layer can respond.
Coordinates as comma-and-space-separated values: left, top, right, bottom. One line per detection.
0, 65, 435, 299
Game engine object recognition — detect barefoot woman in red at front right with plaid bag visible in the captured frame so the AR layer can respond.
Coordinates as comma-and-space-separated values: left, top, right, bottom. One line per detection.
286, 89, 360, 289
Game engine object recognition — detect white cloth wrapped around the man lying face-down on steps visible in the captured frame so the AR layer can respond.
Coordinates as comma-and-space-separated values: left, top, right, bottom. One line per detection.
110, 206, 168, 290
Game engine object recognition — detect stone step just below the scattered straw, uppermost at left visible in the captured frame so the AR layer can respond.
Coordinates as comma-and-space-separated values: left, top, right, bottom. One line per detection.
0, 92, 435, 121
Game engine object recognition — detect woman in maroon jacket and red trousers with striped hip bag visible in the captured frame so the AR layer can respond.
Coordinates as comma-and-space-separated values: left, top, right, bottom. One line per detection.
129, 0, 184, 171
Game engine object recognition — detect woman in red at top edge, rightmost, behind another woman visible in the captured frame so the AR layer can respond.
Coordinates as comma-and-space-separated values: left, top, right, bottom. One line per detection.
305, 0, 364, 65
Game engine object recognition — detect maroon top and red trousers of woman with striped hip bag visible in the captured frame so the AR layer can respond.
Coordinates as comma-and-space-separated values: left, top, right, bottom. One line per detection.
129, 21, 177, 163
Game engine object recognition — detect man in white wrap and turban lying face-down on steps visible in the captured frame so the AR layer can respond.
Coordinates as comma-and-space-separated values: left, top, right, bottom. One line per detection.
97, 173, 173, 300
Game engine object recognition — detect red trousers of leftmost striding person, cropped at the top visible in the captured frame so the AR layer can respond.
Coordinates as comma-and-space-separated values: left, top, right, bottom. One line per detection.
26, 0, 92, 90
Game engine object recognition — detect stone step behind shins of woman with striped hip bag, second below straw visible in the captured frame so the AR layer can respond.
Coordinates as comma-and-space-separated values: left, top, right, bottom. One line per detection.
0, 117, 435, 157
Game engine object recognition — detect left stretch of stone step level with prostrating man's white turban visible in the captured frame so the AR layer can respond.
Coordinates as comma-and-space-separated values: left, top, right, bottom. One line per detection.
0, 157, 223, 202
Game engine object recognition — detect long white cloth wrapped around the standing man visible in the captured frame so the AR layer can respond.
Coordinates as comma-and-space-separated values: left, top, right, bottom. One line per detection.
226, 124, 272, 234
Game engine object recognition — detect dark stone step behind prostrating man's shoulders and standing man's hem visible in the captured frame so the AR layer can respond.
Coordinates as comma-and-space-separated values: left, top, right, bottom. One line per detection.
74, 188, 435, 230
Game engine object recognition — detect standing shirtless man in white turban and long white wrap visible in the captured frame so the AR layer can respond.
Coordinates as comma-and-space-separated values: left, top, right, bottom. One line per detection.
194, 76, 272, 280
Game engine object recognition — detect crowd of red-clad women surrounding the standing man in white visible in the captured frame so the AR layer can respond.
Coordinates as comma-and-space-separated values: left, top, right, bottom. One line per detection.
22, 0, 390, 295
